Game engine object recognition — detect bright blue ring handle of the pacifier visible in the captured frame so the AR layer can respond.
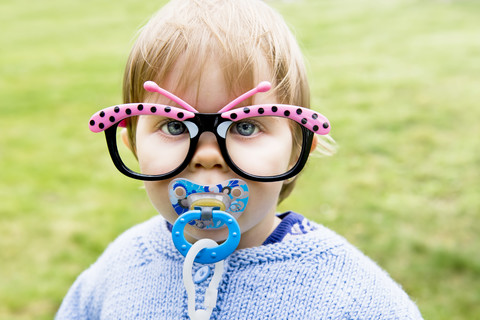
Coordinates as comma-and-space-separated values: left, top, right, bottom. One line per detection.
172, 210, 240, 264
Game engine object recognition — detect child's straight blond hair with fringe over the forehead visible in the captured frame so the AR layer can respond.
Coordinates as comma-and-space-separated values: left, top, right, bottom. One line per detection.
123, 0, 324, 201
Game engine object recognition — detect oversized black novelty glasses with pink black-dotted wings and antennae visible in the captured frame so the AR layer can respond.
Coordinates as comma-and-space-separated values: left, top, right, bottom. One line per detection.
90, 81, 330, 182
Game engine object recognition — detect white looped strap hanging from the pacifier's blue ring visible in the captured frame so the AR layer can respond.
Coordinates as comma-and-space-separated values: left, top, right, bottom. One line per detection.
183, 239, 224, 320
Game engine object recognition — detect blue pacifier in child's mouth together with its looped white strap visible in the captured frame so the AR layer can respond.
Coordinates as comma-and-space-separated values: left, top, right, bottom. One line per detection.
168, 179, 248, 320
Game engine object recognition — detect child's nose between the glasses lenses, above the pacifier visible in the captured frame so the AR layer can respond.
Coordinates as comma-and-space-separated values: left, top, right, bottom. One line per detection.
188, 132, 228, 172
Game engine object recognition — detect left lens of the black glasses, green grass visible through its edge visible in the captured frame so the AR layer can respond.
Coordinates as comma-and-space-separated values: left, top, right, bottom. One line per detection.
117, 115, 190, 175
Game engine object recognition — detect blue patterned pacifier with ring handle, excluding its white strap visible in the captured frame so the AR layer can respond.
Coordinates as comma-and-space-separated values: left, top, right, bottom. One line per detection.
168, 179, 248, 264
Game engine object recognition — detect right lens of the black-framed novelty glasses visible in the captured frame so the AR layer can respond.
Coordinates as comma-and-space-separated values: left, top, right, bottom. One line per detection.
226, 116, 303, 177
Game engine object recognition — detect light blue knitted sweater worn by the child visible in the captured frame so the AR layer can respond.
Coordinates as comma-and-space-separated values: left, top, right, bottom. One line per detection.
57, 216, 422, 320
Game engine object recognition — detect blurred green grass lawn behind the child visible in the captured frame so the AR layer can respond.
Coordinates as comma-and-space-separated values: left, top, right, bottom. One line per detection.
0, 0, 480, 319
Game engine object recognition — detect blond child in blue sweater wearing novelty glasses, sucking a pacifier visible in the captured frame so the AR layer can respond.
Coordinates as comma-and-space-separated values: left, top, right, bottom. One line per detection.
57, 0, 421, 319
